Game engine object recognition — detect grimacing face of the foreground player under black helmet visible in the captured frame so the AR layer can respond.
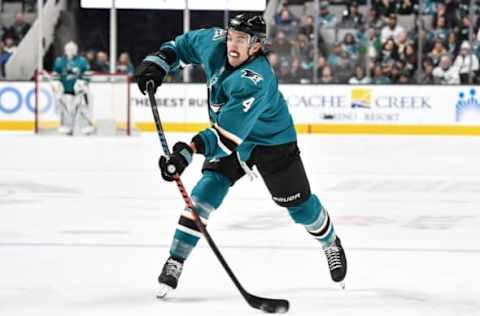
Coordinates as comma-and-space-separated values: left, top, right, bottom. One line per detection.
227, 31, 260, 67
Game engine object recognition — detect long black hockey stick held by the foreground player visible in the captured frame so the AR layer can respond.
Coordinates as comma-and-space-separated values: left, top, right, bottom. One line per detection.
147, 80, 290, 313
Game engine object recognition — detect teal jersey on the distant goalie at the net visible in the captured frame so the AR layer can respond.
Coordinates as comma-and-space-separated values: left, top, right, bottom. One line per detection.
53, 55, 90, 94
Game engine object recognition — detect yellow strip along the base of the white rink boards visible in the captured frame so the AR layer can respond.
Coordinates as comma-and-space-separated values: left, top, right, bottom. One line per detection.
0, 121, 480, 136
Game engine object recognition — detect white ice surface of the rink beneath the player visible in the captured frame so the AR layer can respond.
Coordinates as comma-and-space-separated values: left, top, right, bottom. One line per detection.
0, 133, 480, 316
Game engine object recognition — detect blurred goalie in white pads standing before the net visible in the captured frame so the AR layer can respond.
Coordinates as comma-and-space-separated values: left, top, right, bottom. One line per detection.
52, 41, 95, 135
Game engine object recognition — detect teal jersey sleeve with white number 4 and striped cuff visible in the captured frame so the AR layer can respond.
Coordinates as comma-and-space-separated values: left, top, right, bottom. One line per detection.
199, 72, 269, 158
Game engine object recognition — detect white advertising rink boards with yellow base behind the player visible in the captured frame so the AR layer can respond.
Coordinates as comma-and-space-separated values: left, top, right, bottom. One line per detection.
0, 82, 480, 135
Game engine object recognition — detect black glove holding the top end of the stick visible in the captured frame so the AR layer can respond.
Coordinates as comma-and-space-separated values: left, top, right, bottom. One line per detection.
134, 53, 168, 94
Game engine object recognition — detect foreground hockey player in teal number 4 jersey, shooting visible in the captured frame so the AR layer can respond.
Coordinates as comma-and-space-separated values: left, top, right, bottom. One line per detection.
136, 14, 347, 298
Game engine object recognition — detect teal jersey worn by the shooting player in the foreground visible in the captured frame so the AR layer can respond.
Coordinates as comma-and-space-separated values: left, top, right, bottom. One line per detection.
162, 28, 296, 161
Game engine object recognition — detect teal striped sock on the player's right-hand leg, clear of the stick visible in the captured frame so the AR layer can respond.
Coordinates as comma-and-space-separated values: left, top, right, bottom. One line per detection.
288, 194, 336, 247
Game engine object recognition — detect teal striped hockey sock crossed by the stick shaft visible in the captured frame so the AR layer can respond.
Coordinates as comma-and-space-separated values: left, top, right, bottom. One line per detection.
170, 171, 230, 260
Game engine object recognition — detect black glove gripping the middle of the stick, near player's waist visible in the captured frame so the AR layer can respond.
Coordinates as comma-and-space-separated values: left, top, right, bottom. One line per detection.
158, 142, 193, 181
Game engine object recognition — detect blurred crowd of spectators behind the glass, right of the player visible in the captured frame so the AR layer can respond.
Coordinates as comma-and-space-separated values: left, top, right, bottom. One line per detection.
268, 0, 480, 84
